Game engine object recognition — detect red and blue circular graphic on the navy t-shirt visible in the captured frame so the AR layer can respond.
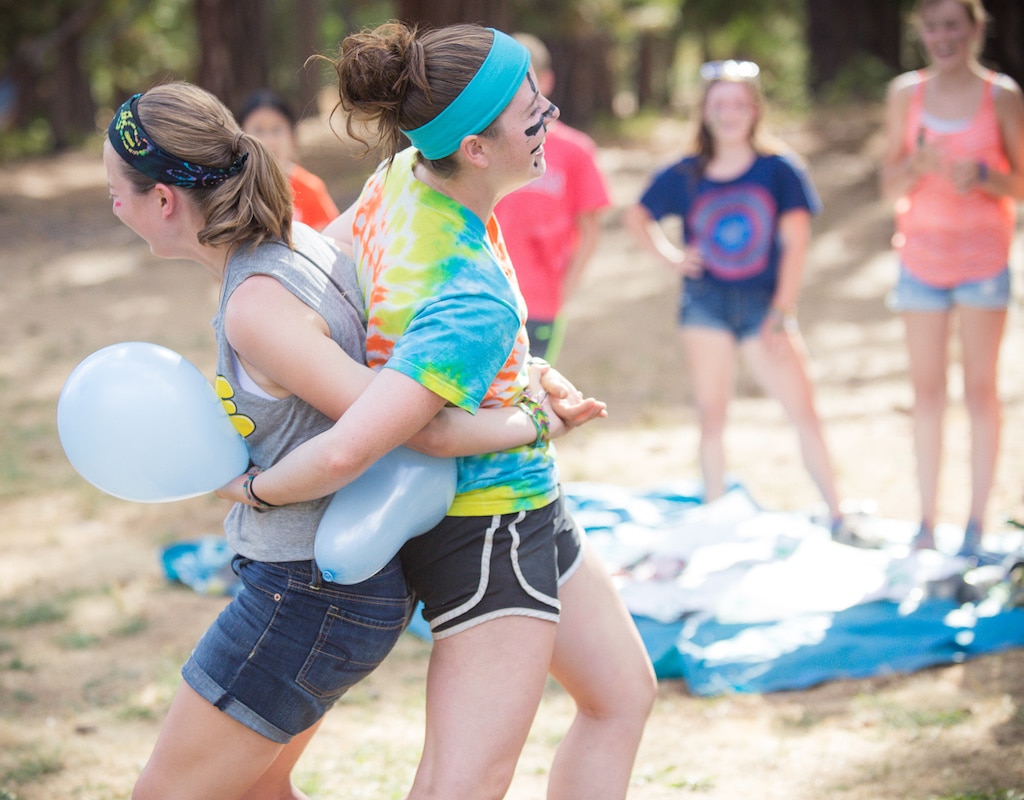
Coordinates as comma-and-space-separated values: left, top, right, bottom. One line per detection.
689, 183, 775, 281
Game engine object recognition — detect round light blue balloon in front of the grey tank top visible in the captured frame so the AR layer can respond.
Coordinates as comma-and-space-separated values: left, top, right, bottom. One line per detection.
57, 342, 249, 503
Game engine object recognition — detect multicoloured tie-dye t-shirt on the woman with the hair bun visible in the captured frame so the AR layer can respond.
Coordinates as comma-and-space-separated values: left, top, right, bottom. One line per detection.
352, 149, 558, 516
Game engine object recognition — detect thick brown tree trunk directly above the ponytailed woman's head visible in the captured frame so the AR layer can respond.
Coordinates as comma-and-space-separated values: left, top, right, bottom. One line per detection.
195, 0, 270, 115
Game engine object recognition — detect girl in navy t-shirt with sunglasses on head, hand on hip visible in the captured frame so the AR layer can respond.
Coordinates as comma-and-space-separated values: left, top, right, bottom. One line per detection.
627, 61, 845, 536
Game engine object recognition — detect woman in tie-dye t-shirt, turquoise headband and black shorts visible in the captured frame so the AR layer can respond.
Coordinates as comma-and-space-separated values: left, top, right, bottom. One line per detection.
231, 24, 656, 800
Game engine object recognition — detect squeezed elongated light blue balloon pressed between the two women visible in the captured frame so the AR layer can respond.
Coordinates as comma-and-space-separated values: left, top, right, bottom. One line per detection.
313, 447, 458, 584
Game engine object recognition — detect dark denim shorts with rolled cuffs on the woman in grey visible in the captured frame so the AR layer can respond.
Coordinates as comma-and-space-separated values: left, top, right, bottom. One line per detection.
181, 556, 413, 744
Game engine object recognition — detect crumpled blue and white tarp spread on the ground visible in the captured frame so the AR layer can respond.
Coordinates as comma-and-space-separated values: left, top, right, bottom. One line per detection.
162, 483, 1024, 696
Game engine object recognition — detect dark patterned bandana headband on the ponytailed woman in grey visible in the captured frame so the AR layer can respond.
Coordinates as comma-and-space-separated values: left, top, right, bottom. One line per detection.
106, 93, 249, 188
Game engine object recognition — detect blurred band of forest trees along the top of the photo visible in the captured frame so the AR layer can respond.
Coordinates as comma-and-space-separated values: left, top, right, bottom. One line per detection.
0, 0, 1024, 159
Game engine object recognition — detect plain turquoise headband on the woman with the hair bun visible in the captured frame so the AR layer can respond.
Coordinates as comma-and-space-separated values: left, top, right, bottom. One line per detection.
402, 28, 529, 161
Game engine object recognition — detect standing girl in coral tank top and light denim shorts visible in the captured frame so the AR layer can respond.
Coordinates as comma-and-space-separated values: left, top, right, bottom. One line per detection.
882, 0, 1024, 558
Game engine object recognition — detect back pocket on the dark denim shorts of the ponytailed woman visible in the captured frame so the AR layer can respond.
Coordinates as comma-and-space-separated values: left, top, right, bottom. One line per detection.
296, 594, 406, 700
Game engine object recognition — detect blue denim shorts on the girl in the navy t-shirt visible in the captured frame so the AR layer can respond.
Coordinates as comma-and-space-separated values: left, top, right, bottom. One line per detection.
679, 280, 774, 339
